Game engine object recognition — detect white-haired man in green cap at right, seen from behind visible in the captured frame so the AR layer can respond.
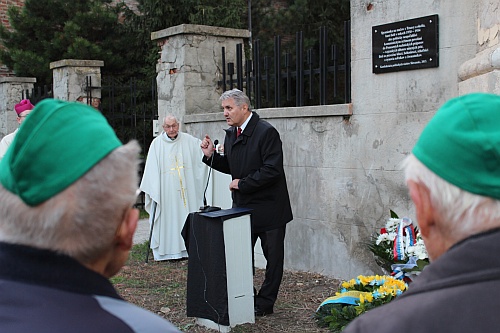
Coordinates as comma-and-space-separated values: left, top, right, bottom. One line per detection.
344, 93, 500, 333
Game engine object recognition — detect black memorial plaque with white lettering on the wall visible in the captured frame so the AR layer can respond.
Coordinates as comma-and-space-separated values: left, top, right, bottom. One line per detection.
372, 15, 439, 74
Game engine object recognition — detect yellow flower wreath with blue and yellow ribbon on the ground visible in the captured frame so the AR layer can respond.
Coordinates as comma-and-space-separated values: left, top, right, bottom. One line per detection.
315, 275, 408, 332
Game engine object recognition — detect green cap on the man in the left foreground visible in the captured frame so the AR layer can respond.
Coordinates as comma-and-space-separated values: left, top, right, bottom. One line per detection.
0, 99, 121, 206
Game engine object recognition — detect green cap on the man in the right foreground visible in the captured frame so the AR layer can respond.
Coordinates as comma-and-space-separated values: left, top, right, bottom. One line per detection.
413, 93, 500, 199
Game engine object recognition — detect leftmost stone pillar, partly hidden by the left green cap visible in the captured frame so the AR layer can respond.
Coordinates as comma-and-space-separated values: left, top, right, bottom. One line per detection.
0, 77, 36, 139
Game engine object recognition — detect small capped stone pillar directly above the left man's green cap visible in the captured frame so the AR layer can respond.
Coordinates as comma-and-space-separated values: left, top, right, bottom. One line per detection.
50, 59, 104, 104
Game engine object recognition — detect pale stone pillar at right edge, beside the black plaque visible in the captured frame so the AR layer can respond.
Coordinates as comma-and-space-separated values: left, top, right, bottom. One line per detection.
458, 0, 500, 95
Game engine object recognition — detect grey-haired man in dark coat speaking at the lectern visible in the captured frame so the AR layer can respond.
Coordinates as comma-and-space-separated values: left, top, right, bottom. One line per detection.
201, 89, 293, 316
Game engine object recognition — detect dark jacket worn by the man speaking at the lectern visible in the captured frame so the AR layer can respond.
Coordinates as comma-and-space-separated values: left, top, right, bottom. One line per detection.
203, 112, 293, 232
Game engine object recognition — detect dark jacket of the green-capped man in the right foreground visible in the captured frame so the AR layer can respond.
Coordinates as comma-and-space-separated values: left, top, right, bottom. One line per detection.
344, 229, 500, 333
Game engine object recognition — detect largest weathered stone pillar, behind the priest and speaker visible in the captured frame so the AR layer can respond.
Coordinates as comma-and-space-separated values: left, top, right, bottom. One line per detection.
151, 24, 250, 127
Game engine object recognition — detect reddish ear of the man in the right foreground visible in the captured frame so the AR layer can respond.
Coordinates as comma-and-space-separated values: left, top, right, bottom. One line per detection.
407, 180, 434, 237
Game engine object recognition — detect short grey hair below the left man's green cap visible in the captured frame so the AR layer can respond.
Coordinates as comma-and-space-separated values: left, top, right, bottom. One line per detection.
0, 141, 140, 263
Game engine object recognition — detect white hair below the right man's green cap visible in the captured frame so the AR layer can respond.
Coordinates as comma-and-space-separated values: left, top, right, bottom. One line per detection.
403, 155, 500, 241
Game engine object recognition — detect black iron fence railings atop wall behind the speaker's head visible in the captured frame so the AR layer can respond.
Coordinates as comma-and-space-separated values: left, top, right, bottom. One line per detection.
218, 21, 351, 109
